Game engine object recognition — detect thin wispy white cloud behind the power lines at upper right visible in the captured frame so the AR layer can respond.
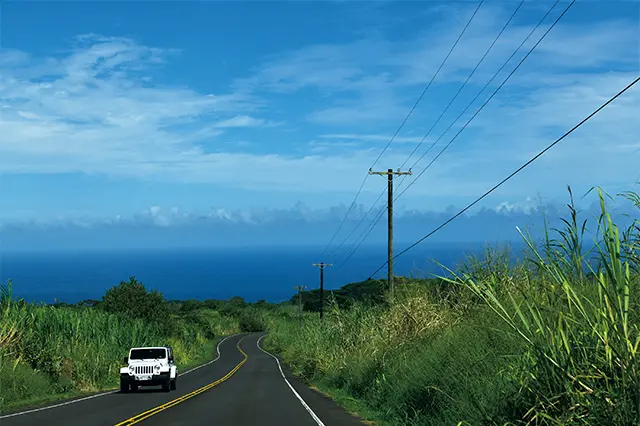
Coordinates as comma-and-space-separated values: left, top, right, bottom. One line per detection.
236, 2, 640, 128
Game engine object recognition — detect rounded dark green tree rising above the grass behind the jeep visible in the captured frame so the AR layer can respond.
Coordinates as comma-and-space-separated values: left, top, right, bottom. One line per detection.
102, 277, 169, 322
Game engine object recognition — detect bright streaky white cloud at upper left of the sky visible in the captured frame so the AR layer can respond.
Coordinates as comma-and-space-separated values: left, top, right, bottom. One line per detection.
0, 36, 257, 169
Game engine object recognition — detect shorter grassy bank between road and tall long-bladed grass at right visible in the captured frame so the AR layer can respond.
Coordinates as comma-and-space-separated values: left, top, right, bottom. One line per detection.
265, 282, 518, 425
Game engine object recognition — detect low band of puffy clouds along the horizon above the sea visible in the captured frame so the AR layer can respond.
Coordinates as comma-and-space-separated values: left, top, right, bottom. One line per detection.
0, 193, 637, 236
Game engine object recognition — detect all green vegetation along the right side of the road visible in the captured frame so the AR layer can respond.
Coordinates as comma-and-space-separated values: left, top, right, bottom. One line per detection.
265, 188, 640, 425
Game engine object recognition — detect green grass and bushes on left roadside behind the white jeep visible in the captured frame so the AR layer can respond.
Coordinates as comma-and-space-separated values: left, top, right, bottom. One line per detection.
0, 277, 261, 412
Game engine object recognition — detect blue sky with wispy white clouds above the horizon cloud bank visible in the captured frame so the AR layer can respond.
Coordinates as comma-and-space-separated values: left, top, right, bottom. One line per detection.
0, 0, 640, 250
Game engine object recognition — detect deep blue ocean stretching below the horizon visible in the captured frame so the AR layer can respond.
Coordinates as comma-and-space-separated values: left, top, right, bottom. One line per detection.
0, 244, 520, 303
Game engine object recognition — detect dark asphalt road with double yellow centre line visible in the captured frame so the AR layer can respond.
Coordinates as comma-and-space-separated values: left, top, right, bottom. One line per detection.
0, 333, 363, 426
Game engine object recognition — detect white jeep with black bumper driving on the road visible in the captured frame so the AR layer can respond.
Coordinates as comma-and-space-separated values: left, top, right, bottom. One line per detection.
120, 346, 178, 393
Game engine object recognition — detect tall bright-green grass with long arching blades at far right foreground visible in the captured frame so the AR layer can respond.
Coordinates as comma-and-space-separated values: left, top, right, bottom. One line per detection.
444, 191, 640, 425
